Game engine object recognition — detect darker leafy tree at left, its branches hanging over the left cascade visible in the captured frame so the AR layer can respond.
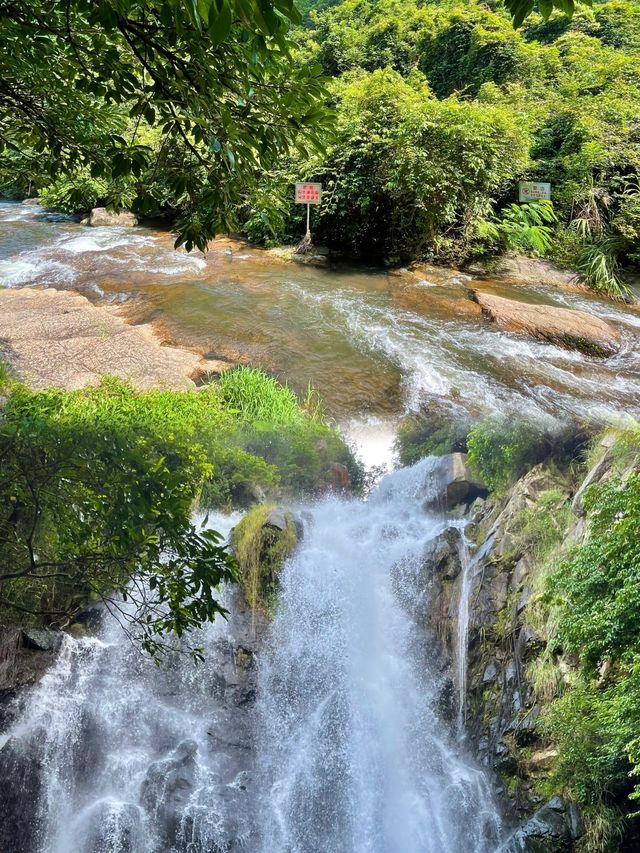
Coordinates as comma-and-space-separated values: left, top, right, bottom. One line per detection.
0, 376, 235, 655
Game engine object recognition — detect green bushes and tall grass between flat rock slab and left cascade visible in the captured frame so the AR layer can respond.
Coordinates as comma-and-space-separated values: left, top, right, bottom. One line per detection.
0, 368, 359, 654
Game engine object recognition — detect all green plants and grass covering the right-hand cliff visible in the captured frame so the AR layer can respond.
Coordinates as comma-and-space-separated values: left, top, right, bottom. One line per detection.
490, 427, 640, 853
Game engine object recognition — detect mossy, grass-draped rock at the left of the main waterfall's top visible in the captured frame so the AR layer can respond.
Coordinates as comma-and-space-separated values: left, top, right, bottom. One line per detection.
231, 504, 298, 614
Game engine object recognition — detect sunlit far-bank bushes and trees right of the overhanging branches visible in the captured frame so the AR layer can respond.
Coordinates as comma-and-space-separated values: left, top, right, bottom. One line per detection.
246, 0, 640, 296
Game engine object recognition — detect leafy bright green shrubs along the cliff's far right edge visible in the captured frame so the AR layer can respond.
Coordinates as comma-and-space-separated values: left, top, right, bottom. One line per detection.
540, 428, 640, 828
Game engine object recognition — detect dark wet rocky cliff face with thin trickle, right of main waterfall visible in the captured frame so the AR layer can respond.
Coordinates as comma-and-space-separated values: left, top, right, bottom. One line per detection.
424, 439, 624, 853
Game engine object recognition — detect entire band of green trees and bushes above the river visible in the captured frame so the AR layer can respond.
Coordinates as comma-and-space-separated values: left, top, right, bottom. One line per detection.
0, 0, 640, 297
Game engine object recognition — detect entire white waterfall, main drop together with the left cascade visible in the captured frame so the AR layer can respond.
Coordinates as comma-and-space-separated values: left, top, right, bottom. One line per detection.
0, 460, 500, 853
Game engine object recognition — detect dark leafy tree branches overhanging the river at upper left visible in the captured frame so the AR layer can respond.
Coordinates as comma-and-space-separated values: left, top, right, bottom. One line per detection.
0, 0, 326, 248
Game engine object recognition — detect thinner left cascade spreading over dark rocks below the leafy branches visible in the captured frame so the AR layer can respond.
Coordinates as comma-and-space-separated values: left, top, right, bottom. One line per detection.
0, 519, 260, 853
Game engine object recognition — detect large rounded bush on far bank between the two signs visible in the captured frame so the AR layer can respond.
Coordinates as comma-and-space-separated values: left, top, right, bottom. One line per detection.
242, 69, 526, 263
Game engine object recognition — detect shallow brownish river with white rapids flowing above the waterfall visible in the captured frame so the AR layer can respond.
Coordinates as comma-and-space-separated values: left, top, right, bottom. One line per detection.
0, 203, 640, 440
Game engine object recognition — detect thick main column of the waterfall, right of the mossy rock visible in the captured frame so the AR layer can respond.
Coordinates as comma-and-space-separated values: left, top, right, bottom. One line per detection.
259, 460, 499, 853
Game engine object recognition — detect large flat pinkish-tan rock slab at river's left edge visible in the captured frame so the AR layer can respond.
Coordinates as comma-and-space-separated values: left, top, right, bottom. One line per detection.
0, 288, 230, 391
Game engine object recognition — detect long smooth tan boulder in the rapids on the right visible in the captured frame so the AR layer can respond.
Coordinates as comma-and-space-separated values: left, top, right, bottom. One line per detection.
471, 290, 620, 357
